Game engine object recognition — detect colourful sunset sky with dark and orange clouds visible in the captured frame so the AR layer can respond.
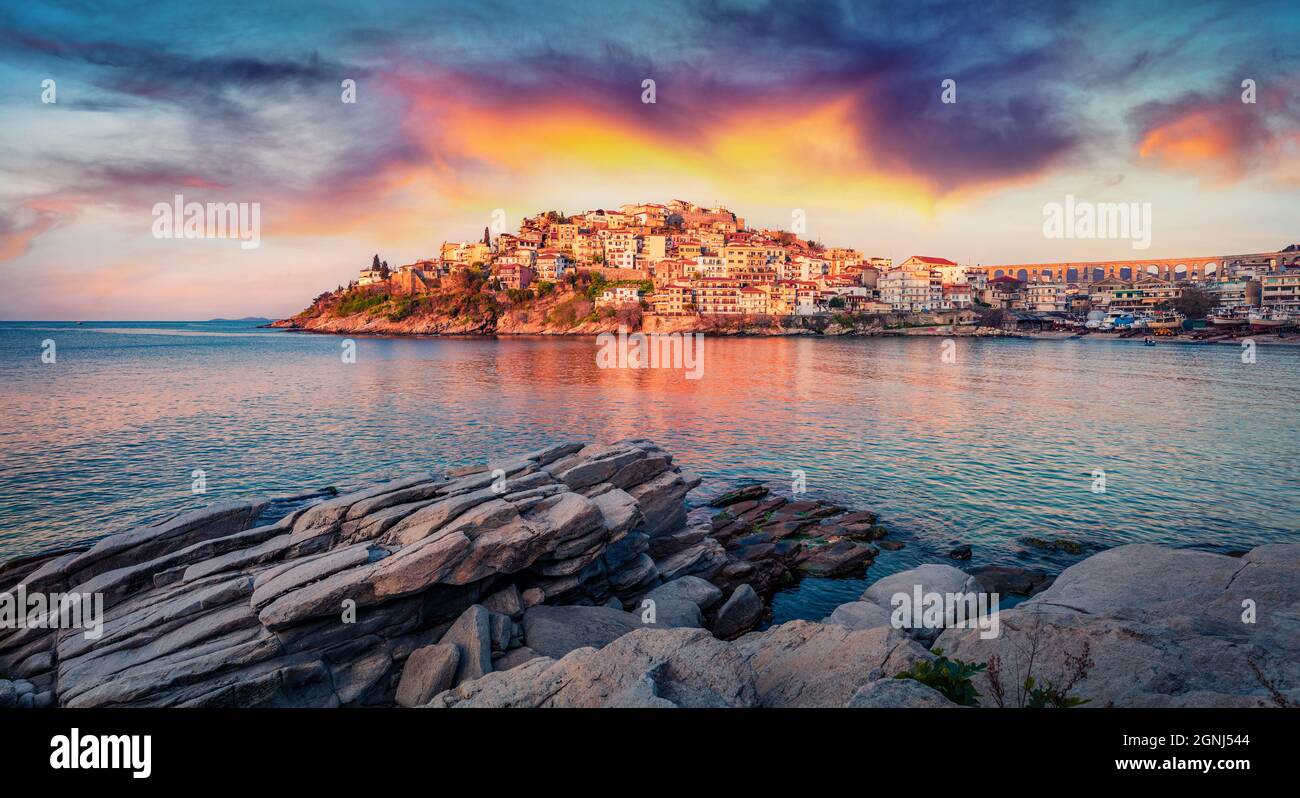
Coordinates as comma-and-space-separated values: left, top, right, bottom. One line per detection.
0, 0, 1300, 320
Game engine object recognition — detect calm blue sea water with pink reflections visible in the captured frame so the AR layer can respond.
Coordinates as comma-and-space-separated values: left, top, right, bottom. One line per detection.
0, 322, 1300, 620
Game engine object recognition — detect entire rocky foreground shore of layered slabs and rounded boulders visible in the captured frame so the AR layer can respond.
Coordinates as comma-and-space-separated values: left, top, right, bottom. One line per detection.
0, 439, 1300, 707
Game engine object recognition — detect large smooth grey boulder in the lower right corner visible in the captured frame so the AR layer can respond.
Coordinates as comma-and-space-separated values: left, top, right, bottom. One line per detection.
935, 543, 1300, 707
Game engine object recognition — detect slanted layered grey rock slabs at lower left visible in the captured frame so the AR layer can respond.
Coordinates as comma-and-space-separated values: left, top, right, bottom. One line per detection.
0, 441, 697, 706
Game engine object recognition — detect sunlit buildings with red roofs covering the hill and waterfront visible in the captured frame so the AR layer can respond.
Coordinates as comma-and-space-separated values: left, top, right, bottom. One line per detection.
338, 199, 1300, 324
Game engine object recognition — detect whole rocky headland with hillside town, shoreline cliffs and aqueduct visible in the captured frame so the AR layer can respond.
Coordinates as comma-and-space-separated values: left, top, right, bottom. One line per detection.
277, 200, 1300, 334
